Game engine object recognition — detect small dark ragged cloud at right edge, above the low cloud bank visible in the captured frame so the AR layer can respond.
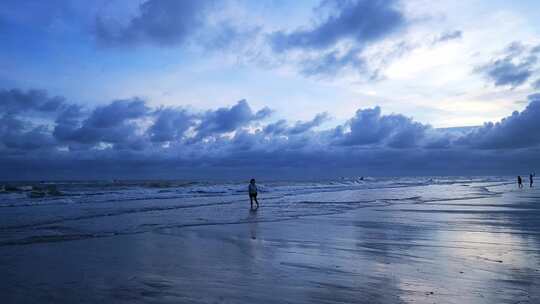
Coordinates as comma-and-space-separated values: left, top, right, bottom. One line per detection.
476, 42, 538, 88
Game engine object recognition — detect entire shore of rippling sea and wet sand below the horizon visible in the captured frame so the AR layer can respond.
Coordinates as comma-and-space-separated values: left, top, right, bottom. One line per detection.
0, 177, 540, 303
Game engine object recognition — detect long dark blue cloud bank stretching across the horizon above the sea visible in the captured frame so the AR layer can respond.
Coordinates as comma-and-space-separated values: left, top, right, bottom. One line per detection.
0, 89, 540, 180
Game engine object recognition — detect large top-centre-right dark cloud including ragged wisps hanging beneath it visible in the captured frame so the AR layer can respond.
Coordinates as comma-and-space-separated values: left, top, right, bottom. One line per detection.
268, 0, 408, 80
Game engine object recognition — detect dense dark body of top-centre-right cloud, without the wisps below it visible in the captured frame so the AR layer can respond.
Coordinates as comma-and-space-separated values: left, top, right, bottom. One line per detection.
271, 0, 405, 52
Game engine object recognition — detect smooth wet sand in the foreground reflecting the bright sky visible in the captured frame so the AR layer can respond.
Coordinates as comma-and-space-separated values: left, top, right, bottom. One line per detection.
0, 182, 540, 304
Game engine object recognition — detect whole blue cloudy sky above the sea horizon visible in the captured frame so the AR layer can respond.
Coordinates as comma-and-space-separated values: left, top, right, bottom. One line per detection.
0, 0, 540, 180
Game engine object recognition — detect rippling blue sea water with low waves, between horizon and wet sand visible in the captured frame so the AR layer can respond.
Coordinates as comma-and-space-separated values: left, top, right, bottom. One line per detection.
0, 176, 515, 246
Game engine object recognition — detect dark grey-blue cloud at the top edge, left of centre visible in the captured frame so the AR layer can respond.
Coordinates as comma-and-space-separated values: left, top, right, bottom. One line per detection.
96, 0, 213, 46
